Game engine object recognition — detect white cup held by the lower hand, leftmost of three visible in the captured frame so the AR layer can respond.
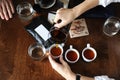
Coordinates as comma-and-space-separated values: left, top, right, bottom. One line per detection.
49, 44, 64, 59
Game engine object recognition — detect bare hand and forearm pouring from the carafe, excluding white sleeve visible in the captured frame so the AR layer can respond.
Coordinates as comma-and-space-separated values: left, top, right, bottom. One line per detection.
54, 0, 99, 28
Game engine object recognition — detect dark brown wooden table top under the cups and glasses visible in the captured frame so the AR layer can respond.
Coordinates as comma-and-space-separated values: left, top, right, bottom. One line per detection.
0, 0, 120, 80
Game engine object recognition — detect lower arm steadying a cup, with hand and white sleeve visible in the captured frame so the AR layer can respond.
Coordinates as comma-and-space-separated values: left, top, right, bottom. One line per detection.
48, 55, 115, 80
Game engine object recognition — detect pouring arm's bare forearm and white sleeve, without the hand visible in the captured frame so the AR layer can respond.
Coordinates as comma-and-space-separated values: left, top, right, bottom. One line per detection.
72, 0, 120, 17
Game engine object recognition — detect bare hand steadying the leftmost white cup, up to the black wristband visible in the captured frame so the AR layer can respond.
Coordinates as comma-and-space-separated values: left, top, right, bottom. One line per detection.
49, 55, 76, 80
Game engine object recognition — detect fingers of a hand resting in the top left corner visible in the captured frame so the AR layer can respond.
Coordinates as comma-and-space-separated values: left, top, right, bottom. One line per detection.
0, 0, 14, 20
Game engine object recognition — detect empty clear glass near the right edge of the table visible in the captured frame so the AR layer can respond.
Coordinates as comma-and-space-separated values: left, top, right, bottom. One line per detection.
103, 16, 120, 36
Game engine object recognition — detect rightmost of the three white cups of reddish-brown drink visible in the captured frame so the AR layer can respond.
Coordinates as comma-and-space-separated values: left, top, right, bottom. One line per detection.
82, 43, 97, 62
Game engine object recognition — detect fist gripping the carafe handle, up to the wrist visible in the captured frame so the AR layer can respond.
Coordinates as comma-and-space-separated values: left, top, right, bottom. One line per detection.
54, 8, 76, 28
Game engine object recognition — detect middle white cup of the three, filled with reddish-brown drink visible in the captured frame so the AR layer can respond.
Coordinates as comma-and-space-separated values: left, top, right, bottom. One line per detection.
65, 45, 80, 63
